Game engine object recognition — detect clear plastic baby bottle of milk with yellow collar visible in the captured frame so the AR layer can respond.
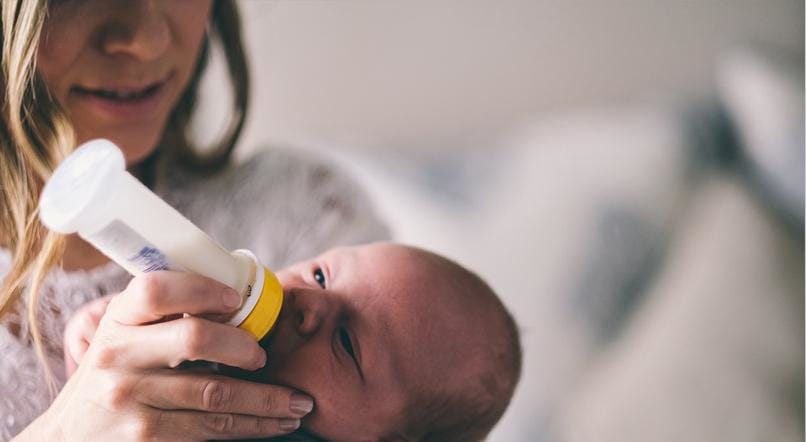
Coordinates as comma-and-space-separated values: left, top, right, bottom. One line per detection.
39, 140, 283, 340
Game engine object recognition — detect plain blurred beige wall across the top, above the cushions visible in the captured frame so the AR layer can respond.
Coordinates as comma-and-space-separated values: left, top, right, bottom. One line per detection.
224, 0, 804, 155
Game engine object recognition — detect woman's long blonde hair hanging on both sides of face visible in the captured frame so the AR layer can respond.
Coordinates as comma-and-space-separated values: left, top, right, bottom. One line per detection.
0, 0, 249, 394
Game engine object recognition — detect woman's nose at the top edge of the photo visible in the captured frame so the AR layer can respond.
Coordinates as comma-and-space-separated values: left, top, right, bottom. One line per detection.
101, 0, 172, 61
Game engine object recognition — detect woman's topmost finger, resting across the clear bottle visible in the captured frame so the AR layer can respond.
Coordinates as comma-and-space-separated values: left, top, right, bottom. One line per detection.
107, 271, 241, 325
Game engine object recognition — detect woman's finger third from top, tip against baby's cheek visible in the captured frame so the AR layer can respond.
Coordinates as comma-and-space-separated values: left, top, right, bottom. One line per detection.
136, 370, 313, 419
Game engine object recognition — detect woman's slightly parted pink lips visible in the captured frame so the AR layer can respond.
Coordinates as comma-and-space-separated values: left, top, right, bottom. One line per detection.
71, 76, 173, 121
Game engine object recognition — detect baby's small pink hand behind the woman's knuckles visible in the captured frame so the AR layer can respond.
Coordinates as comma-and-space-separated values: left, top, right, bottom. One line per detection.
64, 295, 114, 378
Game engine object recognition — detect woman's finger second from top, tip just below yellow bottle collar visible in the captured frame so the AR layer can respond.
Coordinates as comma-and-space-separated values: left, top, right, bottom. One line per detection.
88, 317, 266, 370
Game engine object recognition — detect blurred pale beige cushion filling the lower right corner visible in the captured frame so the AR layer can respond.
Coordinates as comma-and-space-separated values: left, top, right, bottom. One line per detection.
554, 177, 803, 442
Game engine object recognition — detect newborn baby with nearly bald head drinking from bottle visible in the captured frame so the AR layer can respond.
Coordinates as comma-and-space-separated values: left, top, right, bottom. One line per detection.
66, 243, 521, 441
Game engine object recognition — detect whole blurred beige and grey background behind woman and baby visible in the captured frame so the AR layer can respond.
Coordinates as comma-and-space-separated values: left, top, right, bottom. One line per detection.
198, 0, 804, 441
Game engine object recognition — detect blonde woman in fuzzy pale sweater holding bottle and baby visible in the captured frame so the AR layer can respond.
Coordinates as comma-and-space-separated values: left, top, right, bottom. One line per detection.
0, 0, 386, 440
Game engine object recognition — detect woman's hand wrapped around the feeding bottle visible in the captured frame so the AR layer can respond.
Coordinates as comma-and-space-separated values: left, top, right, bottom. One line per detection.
20, 271, 313, 441
